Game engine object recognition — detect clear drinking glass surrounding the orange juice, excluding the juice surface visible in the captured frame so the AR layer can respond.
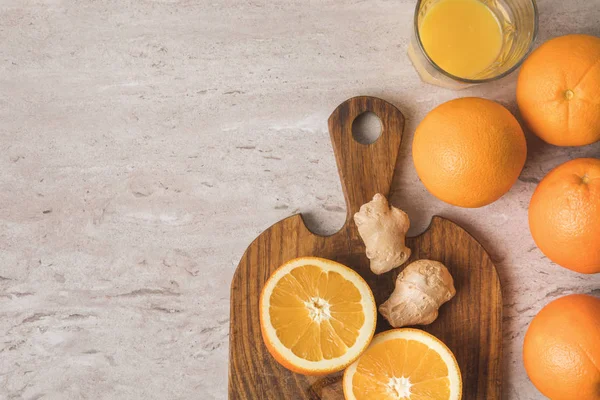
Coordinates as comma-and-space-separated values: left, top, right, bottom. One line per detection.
408, 0, 538, 89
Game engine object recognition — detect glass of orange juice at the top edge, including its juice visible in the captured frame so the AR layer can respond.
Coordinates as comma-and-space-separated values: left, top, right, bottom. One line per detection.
408, 0, 538, 89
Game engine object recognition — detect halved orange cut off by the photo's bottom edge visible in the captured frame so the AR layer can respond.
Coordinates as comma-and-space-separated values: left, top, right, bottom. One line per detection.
344, 329, 462, 400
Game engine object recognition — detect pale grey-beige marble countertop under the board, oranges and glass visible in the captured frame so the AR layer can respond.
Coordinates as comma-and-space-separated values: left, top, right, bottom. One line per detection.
0, 0, 600, 400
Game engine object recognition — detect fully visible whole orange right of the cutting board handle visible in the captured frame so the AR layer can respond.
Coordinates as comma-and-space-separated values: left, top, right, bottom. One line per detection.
412, 97, 527, 207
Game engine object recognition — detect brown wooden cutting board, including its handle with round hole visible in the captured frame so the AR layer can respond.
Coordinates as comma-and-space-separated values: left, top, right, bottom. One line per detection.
229, 97, 502, 400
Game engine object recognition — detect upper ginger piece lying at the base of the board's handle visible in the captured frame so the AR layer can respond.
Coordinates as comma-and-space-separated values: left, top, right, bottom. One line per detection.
354, 193, 410, 275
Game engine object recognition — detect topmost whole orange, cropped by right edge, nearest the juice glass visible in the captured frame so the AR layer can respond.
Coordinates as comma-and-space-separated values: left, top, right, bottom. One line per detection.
517, 35, 600, 146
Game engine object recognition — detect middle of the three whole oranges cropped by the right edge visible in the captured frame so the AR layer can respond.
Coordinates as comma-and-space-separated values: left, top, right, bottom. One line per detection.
529, 158, 600, 274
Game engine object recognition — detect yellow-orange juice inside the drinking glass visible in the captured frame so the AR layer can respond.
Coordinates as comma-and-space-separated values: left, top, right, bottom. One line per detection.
419, 0, 503, 79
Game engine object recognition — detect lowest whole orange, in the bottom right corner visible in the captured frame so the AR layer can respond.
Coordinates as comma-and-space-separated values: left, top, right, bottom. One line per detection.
523, 294, 600, 400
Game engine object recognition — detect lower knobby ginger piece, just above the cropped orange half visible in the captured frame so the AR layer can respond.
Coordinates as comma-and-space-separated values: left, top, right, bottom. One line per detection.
379, 260, 456, 328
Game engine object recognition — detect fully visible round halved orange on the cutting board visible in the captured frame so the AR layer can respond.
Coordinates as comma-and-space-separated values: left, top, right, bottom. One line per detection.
260, 257, 377, 375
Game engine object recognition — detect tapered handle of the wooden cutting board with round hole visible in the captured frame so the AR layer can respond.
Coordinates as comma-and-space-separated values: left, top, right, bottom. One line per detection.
329, 96, 404, 227
